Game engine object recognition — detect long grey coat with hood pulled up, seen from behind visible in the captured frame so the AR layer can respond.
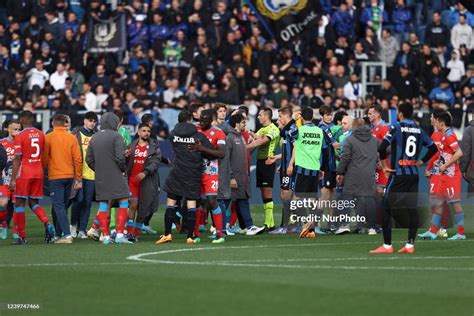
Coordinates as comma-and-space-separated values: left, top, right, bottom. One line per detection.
86, 112, 130, 201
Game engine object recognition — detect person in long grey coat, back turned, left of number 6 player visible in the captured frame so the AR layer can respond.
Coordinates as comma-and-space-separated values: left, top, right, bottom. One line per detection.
336, 118, 378, 235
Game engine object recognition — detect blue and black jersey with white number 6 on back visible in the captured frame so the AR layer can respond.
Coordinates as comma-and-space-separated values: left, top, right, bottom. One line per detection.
384, 120, 433, 175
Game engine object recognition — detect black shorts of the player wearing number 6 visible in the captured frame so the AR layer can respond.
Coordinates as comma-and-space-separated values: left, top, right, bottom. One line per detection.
384, 175, 419, 208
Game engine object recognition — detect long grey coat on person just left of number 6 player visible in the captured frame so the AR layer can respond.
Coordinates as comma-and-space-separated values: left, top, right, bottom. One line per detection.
337, 125, 378, 196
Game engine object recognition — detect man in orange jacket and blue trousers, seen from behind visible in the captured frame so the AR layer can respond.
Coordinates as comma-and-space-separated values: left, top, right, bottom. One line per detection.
43, 114, 82, 244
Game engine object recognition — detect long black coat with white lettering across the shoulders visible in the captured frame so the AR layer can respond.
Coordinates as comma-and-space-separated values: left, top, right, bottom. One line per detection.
163, 123, 211, 200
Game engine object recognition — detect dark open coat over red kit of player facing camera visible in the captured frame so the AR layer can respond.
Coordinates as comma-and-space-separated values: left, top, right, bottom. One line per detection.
127, 139, 161, 222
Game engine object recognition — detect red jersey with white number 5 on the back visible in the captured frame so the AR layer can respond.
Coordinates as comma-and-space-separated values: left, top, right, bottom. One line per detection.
15, 127, 44, 179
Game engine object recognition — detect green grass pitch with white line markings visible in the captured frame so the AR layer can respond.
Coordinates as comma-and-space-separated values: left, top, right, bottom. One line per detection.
0, 207, 474, 316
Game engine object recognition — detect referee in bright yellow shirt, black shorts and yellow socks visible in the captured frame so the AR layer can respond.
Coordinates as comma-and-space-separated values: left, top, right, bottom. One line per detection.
247, 108, 280, 230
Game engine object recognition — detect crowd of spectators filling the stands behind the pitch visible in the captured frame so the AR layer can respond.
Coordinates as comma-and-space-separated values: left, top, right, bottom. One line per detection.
0, 0, 474, 137
